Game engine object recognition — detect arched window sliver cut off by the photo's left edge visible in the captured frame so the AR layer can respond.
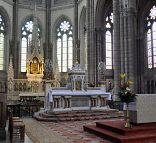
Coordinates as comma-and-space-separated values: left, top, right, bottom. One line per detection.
0, 14, 5, 70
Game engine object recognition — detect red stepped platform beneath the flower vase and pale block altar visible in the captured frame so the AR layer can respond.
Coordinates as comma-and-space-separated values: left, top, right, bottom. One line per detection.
83, 119, 156, 143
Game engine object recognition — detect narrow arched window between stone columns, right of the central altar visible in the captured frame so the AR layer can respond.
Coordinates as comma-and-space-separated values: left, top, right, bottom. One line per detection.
105, 13, 113, 69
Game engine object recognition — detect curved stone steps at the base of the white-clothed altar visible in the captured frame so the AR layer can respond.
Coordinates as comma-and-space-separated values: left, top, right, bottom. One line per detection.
34, 109, 123, 122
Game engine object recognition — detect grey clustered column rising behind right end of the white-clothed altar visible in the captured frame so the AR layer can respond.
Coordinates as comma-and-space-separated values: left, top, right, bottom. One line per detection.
87, 0, 97, 83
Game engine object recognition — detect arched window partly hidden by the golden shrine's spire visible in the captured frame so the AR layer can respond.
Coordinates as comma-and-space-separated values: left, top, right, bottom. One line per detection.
21, 18, 40, 72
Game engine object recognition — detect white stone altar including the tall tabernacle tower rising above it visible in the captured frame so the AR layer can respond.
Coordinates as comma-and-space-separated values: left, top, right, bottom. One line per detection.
45, 62, 111, 111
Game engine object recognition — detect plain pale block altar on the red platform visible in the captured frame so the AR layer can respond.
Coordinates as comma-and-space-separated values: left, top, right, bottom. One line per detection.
129, 94, 156, 124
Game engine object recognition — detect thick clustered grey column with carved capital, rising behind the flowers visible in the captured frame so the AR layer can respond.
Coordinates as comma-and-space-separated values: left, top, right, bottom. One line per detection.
120, 0, 137, 90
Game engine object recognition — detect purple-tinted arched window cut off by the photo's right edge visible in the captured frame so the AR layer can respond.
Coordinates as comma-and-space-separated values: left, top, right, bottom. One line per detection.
146, 6, 156, 69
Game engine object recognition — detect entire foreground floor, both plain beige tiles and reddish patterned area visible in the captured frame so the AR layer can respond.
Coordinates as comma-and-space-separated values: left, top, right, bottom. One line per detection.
24, 119, 114, 143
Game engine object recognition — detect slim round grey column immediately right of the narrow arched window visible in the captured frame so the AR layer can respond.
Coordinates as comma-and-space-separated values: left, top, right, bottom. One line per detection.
113, 0, 121, 94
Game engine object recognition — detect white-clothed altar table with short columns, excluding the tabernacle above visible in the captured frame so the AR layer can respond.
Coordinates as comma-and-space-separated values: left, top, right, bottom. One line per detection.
48, 90, 110, 111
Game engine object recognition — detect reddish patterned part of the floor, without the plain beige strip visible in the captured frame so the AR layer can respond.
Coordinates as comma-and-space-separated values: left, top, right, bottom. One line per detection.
42, 120, 110, 143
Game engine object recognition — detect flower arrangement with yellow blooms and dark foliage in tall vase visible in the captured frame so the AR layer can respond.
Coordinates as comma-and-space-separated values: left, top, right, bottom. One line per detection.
118, 73, 136, 104
